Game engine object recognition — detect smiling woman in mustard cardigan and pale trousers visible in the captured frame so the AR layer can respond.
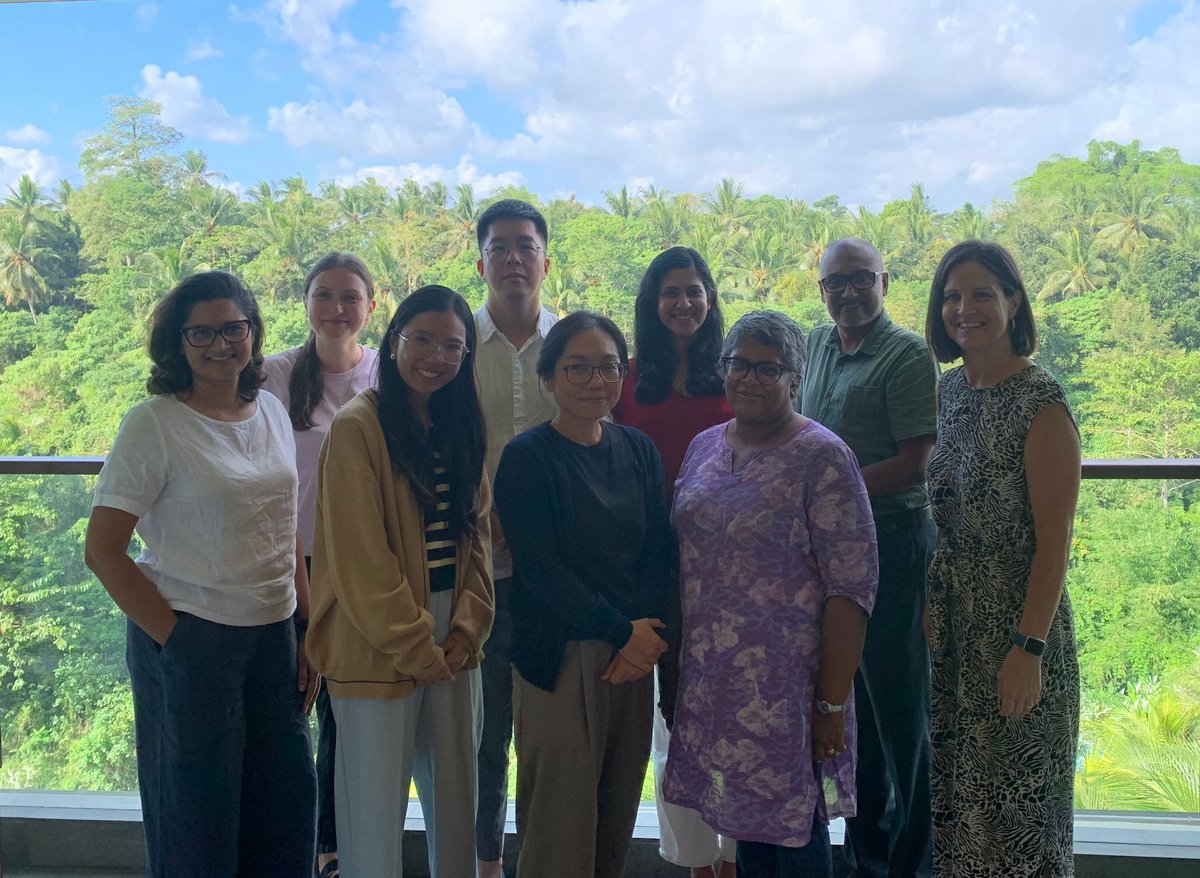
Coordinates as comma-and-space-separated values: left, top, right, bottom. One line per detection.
308, 287, 494, 876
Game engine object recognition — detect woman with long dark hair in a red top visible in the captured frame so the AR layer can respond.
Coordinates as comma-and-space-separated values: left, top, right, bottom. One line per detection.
612, 247, 734, 878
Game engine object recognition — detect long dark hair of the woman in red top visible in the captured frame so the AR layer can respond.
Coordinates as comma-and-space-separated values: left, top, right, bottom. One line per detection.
634, 247, 725, 405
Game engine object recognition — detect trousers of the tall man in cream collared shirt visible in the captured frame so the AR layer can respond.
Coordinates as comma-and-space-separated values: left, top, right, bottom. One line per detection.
475, 578, 512, 861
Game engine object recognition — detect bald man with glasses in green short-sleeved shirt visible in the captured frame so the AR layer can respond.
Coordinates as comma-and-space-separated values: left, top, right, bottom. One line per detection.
800, 237, 937, 878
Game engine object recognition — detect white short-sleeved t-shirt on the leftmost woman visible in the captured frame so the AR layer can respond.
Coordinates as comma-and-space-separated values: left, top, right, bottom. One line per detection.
91, 392, 296, 626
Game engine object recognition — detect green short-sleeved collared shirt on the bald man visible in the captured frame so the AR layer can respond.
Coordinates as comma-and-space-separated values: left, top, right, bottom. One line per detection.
800, 311, 938, 522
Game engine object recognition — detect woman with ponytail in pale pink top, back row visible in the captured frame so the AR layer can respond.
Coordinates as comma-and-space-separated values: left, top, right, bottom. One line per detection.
263, 253, 379, 878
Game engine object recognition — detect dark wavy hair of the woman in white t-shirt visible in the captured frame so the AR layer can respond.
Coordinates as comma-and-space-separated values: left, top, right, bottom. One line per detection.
146, 271, 264, 403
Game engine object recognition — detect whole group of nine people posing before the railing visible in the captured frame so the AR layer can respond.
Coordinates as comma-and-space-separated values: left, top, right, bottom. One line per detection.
86, 200, 1079, 878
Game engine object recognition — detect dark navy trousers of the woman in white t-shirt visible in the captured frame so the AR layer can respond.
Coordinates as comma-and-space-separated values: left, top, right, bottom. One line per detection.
125, 613, 317, 878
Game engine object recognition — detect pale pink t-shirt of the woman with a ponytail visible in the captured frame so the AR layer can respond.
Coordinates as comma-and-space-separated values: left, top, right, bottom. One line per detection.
263, 347, 379, 555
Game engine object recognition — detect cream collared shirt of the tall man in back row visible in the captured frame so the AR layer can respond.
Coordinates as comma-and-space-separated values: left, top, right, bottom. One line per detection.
475, 303, 558, 579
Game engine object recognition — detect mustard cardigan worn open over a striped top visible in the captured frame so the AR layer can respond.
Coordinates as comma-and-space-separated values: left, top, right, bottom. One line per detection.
306, 390, 496, 698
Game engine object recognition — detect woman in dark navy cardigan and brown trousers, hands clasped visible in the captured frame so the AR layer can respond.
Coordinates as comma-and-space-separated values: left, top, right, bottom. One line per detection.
496, 312, 673, 878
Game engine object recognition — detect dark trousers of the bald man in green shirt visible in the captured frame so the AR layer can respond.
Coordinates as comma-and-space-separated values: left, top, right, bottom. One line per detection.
842, 522, 935, 878
